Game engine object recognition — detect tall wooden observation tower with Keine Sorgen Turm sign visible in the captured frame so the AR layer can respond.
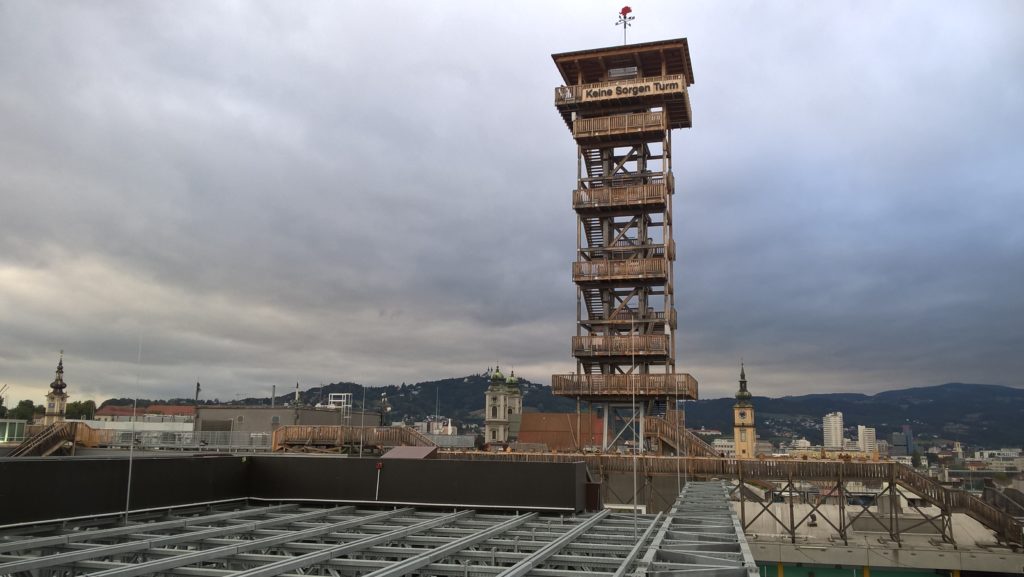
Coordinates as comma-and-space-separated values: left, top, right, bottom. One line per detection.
551, 38, 697, 450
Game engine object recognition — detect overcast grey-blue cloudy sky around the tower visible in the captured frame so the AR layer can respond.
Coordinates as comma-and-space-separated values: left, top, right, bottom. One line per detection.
0, 0, 1024, 406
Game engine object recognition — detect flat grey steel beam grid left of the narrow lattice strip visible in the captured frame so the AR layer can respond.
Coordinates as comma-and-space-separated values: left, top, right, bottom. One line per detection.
0, 503, 650, 577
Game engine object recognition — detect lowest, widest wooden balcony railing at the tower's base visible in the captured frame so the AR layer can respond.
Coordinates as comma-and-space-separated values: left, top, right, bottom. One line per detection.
551, 373, 697, 400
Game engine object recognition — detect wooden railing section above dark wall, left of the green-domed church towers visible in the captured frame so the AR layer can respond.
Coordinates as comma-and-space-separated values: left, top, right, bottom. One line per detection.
272, 425, 436, 451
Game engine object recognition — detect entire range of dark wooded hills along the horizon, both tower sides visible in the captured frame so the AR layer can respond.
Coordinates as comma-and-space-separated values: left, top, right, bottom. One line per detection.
101, 381, 1024, 448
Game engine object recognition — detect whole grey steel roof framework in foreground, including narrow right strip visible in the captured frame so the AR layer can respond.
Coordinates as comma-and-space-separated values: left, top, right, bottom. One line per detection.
0, 483, 757, 577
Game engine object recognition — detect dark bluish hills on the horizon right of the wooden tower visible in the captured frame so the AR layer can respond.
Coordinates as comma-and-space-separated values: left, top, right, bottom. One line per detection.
686, 382, 1024, 447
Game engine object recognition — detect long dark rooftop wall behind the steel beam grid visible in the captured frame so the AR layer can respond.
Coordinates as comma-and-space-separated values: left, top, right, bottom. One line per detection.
0, 455, 586, 526
